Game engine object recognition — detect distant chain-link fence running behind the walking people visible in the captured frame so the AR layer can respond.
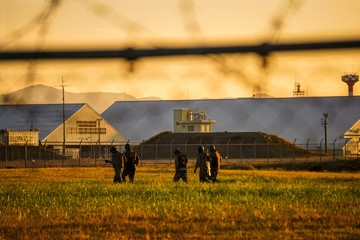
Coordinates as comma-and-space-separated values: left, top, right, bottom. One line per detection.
0, 141, 359, 167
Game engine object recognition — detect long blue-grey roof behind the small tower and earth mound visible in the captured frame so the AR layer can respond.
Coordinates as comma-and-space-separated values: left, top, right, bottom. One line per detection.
102, 96, 360, 143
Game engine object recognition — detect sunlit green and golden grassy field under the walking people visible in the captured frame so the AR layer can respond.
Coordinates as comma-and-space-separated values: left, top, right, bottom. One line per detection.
0, 165, 360, 239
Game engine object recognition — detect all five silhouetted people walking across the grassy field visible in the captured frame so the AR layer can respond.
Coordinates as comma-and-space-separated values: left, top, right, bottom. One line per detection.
105, 144, 222, 183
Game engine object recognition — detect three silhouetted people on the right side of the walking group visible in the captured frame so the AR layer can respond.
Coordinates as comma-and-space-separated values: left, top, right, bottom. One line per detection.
173, 145, 222, 183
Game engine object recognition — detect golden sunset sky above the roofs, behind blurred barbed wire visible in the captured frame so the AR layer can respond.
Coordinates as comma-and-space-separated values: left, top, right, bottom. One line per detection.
0, 0, 360, 99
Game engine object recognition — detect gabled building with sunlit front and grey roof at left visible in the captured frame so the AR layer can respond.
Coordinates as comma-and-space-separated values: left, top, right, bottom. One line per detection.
0, 104, 128, 158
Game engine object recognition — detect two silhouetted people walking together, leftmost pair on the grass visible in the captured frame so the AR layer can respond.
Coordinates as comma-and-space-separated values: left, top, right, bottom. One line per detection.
105, 144, 140, 183
